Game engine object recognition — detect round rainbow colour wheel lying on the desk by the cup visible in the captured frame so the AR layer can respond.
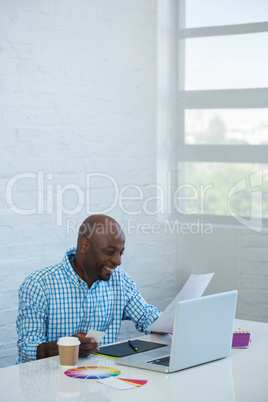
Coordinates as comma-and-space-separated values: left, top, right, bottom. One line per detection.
64, 366, 120, 380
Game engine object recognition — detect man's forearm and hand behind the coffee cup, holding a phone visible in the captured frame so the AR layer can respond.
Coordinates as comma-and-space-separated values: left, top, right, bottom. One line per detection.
36, 332, 99, 359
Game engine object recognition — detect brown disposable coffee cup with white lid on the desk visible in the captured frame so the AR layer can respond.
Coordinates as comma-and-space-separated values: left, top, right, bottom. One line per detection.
57, 336, 80, 370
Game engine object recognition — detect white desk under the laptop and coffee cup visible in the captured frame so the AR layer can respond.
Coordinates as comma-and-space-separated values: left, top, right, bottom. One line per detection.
0, 320, 268, 402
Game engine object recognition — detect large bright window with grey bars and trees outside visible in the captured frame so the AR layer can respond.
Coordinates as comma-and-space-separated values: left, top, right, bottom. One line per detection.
176, 0, 268, 231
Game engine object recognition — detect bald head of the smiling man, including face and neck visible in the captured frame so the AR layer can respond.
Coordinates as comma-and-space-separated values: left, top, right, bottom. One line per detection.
75, 215, 125, 286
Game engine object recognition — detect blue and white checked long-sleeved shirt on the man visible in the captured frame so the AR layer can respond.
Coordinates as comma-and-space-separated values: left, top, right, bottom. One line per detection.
17, 248, 161, 363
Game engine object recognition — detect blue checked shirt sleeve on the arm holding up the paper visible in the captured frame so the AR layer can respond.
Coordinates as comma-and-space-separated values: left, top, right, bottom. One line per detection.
123, 274, 161, 334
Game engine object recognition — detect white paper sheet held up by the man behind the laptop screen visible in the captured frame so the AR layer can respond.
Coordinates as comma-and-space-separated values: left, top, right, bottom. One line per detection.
147, 272, 214, 333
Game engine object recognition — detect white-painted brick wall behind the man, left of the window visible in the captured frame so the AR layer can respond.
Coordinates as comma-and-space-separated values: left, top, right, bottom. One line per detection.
0, 0, 180, 367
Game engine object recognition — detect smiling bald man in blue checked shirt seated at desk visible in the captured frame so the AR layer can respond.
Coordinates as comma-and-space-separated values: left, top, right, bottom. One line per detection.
17, 215, 161, 363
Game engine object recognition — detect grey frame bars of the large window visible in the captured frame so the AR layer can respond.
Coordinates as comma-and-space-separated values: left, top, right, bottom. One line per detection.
175, 0, 268, 227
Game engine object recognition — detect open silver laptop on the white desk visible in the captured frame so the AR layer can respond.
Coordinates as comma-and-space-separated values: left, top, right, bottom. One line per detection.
116, 290, 237, 373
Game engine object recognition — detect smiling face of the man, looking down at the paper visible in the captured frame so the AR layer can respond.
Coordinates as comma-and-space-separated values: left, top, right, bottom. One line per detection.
84, 230, 125, 283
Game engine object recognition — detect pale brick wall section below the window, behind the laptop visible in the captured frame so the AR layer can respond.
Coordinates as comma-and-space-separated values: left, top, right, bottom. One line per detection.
179, 227, 268, 322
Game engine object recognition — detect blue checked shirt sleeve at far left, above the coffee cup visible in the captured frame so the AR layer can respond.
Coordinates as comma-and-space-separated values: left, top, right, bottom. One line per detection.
16, 278, 47, 363
